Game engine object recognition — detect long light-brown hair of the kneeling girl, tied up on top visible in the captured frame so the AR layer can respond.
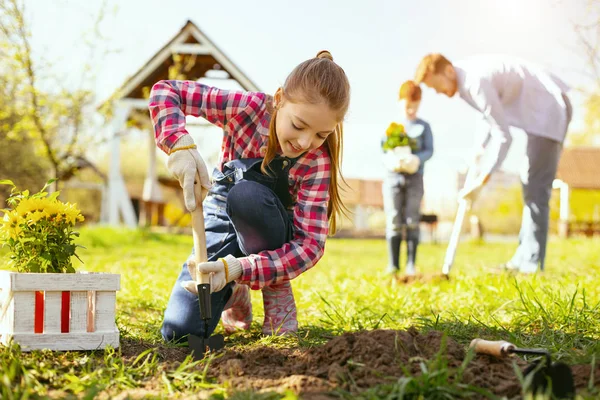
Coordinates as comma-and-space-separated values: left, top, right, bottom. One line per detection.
261, 50, 350, 234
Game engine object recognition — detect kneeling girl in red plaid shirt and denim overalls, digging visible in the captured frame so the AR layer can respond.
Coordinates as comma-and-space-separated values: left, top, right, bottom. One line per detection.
149, 51, 350, 341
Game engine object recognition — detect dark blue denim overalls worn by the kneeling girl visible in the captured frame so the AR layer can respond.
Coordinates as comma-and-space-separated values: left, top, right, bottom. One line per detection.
161, 157, 296, 341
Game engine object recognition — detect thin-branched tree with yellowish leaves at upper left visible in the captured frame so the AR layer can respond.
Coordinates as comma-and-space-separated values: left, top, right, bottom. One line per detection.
0, 0, 111, 189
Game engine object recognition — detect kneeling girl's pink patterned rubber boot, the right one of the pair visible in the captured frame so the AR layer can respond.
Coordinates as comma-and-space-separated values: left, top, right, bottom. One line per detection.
262, 282, 298, 336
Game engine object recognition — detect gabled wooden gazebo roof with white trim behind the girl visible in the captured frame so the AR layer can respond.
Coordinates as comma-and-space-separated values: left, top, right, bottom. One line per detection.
112, 20, 259, 100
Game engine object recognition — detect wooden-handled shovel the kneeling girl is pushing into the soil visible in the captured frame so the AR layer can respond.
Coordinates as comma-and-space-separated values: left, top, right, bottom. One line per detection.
188, 176, 225, 360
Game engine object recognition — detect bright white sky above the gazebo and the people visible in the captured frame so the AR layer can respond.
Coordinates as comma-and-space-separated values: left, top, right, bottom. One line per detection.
26, 0, 590, 212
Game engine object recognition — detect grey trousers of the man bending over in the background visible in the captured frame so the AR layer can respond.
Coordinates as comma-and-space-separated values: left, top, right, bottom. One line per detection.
511, 135, 562, 273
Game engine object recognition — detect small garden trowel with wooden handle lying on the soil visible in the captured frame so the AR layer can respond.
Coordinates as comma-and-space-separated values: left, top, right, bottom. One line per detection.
469, 339, 575, 399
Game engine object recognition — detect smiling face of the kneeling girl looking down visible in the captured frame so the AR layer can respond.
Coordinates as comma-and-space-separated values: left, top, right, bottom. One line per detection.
275, 95, 338, 158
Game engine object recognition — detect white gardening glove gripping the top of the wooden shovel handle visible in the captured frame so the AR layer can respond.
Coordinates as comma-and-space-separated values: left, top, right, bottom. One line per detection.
167, 135, 210, 212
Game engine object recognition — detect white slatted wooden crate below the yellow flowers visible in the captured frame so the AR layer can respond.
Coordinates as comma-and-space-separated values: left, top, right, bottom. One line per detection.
0, 271, 121, 351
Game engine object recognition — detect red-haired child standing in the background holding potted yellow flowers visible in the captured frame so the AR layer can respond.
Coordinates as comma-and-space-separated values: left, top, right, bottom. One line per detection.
383, 81, 433, 275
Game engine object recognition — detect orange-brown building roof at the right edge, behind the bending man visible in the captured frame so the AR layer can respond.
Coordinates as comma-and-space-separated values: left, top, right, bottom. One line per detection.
556, 147, 600, 190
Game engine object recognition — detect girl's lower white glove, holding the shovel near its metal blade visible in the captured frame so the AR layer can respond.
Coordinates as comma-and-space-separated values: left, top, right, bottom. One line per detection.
181, 255, 242, 294
